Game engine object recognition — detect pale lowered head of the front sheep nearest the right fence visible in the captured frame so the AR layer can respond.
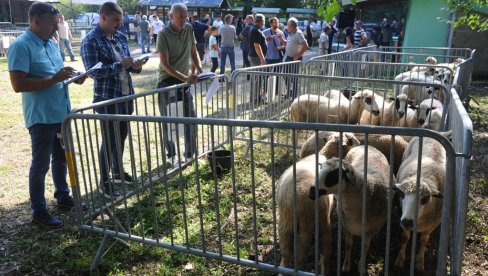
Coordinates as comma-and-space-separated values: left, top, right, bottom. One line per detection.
393, 179, 443, 230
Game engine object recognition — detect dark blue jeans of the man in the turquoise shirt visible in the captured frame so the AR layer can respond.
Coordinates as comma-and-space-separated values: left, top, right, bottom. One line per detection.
29, 123, 69, 215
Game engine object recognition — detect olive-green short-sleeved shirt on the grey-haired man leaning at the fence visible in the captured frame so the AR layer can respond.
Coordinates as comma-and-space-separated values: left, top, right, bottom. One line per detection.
157, 23, 197, 81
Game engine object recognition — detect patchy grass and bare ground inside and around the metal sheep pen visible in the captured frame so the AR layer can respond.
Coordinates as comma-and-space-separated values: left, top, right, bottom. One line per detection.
0, 52, 488, 275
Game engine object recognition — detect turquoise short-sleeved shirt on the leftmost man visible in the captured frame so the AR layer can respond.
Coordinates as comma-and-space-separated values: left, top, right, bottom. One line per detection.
7, 29, 71, 128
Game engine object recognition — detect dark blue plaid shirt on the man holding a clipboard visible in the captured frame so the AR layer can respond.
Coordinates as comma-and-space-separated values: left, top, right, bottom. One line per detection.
80, 26, 140, 103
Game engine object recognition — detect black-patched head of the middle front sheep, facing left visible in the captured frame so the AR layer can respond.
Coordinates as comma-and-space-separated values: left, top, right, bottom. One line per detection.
308, 157, 354, 200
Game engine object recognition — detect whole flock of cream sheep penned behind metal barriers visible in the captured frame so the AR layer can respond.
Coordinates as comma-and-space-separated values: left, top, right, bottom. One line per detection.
277, 57, 459, 275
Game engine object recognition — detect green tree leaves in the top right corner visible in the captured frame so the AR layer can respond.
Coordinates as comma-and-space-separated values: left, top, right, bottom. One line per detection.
438, 0, 488, 32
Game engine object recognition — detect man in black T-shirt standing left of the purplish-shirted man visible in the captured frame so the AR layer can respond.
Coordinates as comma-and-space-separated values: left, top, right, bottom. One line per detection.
249, 13, 268, 66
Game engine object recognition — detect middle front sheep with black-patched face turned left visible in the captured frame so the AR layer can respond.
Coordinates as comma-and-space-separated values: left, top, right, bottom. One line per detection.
309, 146, 395, 272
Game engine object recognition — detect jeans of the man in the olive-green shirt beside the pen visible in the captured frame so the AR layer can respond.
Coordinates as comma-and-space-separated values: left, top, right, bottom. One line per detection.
158, 77, 197, 158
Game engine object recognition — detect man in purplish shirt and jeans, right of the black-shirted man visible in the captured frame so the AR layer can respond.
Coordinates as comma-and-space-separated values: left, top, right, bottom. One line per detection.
263, 17, 286, 64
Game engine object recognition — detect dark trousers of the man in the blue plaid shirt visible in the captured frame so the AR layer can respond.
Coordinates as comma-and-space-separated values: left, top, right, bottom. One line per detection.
95, 102, 132, 183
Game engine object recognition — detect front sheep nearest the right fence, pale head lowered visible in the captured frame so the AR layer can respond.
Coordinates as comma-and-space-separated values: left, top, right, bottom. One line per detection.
395, 137, 446, 271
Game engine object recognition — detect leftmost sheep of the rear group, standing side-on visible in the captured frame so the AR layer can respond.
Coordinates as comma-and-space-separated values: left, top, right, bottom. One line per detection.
290, 94, 349, 124
